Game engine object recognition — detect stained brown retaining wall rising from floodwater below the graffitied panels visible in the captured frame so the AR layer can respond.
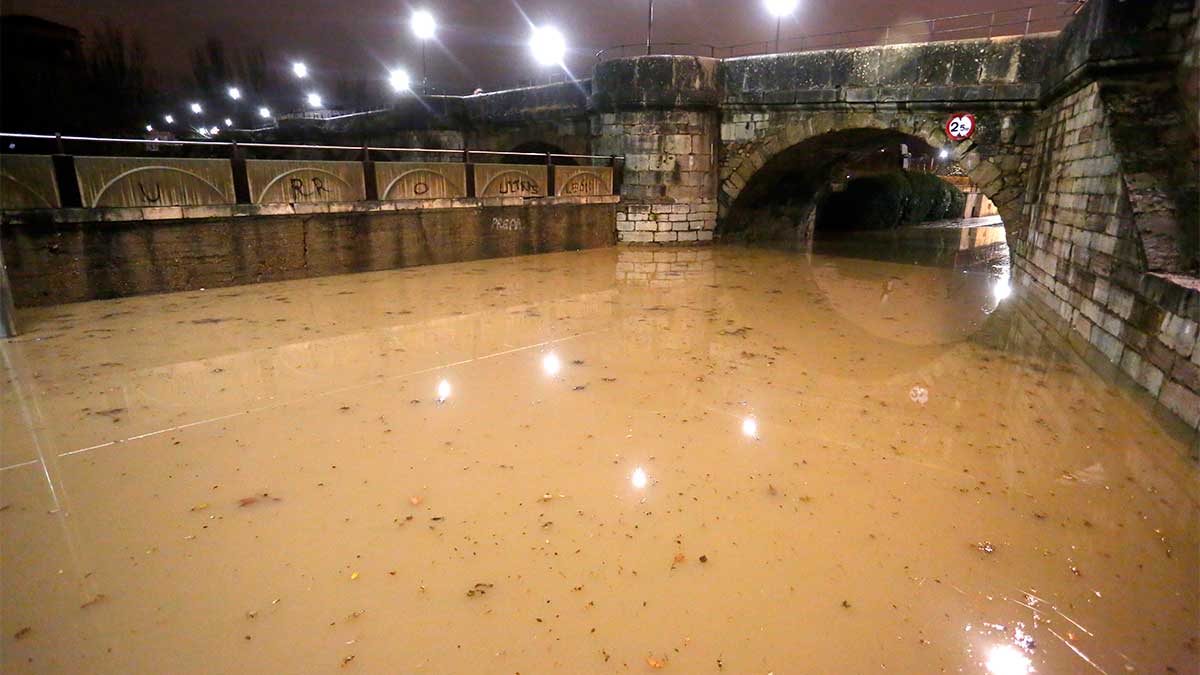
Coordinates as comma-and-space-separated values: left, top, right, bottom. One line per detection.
0, 192, 618, 306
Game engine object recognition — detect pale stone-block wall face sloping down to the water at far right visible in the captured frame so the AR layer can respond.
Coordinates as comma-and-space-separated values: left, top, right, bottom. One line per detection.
1010, 83, 1200, 428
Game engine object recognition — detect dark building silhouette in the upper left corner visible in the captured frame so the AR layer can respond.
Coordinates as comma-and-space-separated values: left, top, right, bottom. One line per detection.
0, 14, 84, 132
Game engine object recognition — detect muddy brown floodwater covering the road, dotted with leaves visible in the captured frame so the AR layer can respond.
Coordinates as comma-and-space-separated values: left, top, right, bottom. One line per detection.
0, 234, 1200, 675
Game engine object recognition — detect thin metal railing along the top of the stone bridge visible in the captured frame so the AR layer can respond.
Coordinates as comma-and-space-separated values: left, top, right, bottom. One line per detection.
596, 0, 1082, 61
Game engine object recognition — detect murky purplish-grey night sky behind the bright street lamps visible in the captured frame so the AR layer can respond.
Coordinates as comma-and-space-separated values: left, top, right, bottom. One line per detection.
0, 0, 1054, 89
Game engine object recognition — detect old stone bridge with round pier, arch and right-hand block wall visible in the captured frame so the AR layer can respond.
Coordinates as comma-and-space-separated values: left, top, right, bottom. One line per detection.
253, 0, 1200, 428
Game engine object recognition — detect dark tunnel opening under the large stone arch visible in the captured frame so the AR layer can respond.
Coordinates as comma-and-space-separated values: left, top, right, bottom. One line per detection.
720, 129, 995, 241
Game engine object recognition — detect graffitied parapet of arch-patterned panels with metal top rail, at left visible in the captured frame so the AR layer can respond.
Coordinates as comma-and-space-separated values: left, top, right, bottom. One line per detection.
0, 133, 624, 210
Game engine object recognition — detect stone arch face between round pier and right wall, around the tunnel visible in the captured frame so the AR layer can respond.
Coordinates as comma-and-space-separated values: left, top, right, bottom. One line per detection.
718, 109, 1028, 241
